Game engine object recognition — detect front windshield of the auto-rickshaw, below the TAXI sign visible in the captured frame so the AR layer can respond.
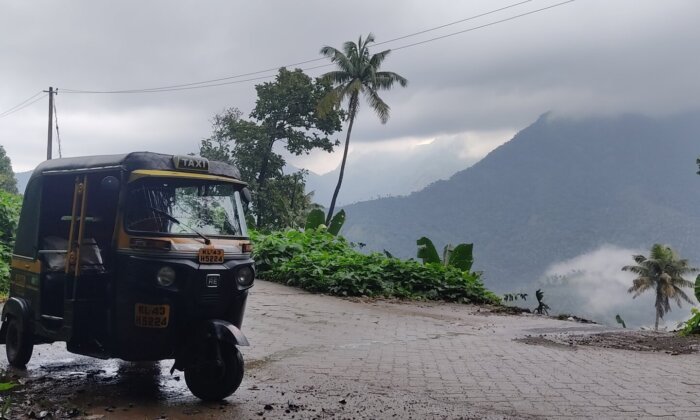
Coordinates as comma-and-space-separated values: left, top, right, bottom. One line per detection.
125, 178, 248, 237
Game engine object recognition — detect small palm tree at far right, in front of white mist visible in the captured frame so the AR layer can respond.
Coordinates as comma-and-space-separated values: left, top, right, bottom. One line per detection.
622, 244, 698, 330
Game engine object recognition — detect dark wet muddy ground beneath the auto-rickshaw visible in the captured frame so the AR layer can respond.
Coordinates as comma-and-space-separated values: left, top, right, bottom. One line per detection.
0, 344, 262, 419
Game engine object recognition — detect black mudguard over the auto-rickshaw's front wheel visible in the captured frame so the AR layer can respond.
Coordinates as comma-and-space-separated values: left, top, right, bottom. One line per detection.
170, 319, 250, 373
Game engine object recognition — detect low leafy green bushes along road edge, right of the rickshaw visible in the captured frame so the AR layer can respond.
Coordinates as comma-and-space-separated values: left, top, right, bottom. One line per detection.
252, 227, 500, 303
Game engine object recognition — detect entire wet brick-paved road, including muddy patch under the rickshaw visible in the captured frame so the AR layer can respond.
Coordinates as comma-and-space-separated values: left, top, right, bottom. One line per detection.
0, 281, 700, 419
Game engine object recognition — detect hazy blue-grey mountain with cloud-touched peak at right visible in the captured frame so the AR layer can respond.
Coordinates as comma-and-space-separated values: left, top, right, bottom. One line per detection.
344, 110, 700, 322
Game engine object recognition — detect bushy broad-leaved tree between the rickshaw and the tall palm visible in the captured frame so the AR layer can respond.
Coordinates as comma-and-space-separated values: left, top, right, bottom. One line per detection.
199, 68, 344, 231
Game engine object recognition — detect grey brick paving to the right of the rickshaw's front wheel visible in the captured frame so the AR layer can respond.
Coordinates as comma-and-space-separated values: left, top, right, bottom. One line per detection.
234, 282, 700, 418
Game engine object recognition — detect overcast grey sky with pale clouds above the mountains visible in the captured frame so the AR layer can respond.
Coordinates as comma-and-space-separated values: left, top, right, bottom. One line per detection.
0, 0, 700, 172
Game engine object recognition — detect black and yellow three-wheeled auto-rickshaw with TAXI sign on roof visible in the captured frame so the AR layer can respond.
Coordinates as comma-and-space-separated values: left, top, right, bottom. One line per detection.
0, 152, 255, 400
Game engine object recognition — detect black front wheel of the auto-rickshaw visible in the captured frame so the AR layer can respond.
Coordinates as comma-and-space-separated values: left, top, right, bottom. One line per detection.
185, 343, 243, 401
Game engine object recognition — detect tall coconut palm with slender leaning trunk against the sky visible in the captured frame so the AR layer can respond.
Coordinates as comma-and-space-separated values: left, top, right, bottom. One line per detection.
319, 33, 408, 224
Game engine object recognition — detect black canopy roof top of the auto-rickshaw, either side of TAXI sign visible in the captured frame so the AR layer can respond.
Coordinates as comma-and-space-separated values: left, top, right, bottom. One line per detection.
30, 152, 241, 180
